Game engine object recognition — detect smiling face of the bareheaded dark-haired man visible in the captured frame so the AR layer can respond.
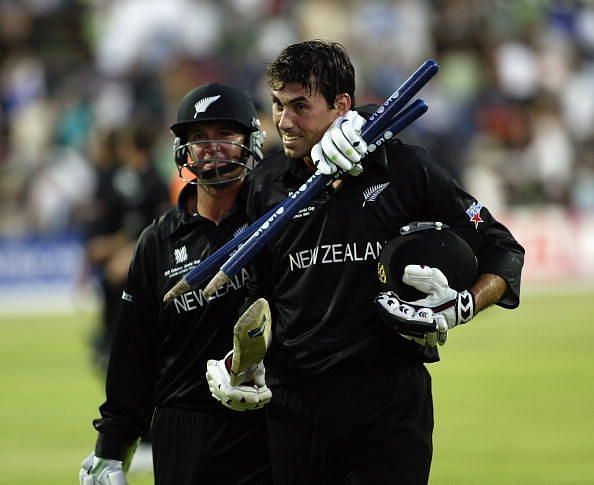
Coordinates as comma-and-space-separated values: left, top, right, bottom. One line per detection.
272, 83, 350, 158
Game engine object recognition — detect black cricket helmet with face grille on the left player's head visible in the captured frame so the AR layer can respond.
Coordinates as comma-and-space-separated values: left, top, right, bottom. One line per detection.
170, 83, 265, 185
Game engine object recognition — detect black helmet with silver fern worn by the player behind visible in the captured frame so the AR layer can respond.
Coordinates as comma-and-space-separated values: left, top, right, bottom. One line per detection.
170, 83, 265, 184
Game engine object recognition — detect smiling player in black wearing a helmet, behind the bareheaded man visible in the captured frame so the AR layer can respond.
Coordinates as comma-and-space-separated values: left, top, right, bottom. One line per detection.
80, 83, 271, 485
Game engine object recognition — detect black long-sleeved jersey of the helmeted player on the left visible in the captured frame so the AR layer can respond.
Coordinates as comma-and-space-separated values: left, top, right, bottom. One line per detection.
94, 185, 248, 457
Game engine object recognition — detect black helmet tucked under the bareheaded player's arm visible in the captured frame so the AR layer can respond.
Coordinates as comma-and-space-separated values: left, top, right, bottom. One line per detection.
378, 222, 478, 301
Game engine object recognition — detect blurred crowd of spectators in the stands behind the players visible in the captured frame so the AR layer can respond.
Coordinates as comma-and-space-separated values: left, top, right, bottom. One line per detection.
0, 0, 594, 236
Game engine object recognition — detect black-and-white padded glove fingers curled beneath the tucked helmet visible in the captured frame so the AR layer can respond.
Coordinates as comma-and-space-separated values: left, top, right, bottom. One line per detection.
375, 291, 448, 347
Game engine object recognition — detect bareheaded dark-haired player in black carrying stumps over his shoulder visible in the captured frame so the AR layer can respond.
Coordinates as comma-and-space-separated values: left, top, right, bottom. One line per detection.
207, 41, 524, 485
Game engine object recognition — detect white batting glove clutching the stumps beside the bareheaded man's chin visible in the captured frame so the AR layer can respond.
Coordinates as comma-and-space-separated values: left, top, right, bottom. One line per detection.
311, 111, 367, 176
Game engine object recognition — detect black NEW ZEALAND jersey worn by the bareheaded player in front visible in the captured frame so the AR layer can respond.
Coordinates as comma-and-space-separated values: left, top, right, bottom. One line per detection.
247, 140, 524, 385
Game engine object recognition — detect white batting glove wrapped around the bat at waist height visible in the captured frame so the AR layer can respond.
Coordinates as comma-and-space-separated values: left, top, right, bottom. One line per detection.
206, 351, 272, 411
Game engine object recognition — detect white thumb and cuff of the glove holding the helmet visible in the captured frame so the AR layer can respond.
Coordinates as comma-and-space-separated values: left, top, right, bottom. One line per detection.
402, 264, 474, 328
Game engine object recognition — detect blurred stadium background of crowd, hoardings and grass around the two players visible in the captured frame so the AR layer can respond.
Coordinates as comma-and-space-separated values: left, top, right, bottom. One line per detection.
0, 0, 594, 485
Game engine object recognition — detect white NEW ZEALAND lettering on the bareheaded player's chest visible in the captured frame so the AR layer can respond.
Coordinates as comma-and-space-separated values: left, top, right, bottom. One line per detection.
289, 241, 383, 271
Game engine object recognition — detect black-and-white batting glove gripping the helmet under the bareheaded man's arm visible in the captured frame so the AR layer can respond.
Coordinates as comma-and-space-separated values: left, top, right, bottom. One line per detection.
375, 265, 474, 347
